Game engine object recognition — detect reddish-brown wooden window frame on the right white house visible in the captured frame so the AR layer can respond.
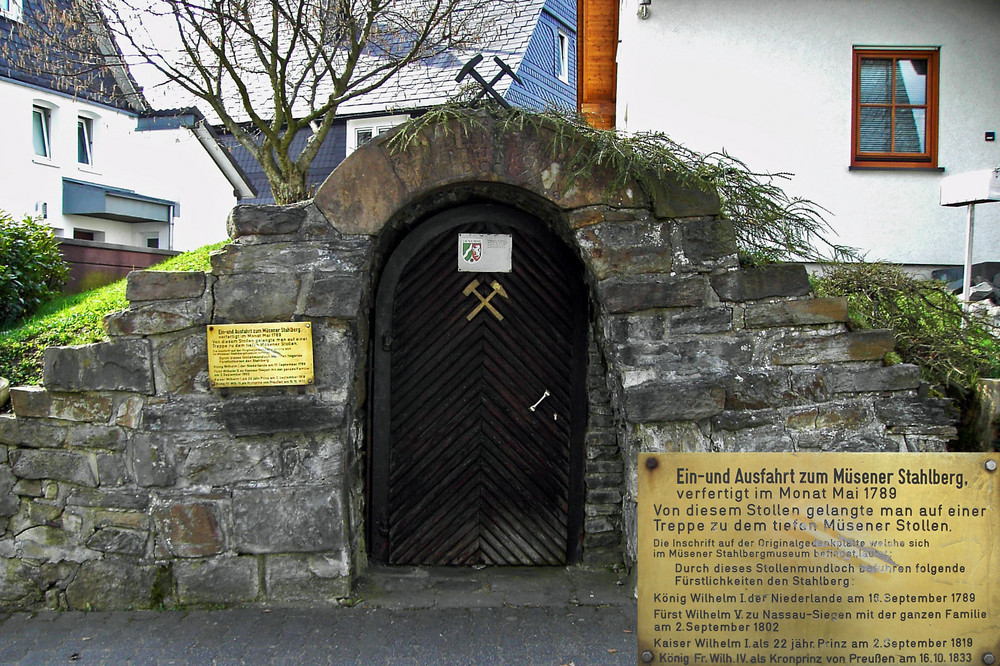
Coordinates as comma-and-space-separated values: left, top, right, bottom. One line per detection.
851, 47, 940, 169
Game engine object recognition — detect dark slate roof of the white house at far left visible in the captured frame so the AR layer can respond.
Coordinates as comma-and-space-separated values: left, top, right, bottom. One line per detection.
0, 0, 148, 111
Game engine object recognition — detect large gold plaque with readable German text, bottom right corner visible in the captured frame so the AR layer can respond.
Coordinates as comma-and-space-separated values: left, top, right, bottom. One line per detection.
638, 453, 1000, 665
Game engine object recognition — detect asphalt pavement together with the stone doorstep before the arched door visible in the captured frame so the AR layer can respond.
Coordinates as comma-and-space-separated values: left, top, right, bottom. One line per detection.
0, 568, 636, 666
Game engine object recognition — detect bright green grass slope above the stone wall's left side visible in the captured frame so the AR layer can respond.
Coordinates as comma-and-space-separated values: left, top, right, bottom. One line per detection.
0, 241, 229, 386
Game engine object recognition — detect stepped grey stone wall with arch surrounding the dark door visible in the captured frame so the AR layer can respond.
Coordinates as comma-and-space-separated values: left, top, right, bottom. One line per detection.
0, 113, 954, 609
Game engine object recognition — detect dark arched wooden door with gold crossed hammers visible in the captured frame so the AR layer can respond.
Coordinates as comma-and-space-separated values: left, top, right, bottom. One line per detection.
370, 204, 588, 565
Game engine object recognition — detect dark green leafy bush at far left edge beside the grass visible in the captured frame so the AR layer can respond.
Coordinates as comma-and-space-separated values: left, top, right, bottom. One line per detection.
0, 211, 69, 328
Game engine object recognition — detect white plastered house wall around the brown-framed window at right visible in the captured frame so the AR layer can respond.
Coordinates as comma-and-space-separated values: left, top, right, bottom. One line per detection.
617, 0, 1000, 265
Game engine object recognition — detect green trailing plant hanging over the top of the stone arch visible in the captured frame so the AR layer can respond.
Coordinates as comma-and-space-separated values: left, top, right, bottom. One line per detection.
387, 102, 860, 264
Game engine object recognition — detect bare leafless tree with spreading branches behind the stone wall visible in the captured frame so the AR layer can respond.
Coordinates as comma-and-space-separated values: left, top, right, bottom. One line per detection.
9, 0, 517, 203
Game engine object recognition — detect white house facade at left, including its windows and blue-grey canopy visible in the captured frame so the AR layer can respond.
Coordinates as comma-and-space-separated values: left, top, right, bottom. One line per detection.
0, 79, 236, 250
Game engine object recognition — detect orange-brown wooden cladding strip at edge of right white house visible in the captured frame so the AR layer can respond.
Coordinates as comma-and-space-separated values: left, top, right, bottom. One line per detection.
577, 0, 618, 129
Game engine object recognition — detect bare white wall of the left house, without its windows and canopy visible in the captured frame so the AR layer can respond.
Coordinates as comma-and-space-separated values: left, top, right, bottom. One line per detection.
0, 81, 236, 250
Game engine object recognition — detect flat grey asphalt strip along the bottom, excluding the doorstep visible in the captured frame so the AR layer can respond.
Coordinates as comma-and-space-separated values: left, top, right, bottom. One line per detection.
0, 604, 636, 666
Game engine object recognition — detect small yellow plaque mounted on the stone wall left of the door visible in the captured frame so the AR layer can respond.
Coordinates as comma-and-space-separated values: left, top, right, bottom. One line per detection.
208, 322, 313, 387
